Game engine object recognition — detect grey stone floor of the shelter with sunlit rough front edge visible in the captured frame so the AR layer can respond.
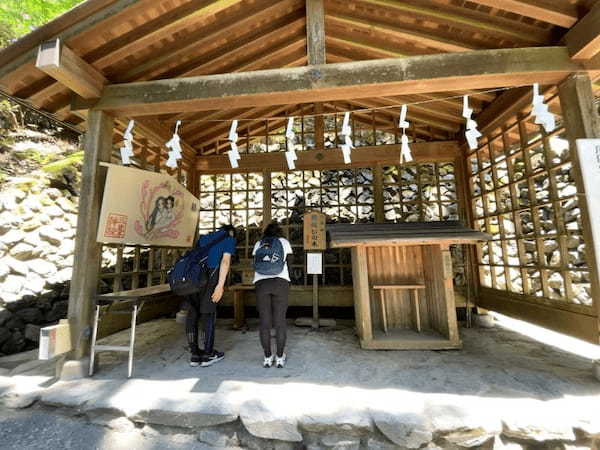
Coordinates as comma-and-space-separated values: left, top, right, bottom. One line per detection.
0, 319, 600, 449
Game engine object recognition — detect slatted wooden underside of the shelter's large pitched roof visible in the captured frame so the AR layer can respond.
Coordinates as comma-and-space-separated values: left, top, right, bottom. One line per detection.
0, 0, 594, 159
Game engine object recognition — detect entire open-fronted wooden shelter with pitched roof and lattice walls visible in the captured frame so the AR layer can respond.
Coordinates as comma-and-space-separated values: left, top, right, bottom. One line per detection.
0, 0, 600, 359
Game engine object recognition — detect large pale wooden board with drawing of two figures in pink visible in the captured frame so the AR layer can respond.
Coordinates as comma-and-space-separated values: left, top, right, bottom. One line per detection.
97, 164, 199, 247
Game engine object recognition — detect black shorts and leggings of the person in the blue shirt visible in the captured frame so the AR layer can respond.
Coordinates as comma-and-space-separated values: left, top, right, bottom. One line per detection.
185, 270, 219, 355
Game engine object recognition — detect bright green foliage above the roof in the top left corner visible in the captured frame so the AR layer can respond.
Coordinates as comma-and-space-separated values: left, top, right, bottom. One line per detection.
0, 0, 82, 43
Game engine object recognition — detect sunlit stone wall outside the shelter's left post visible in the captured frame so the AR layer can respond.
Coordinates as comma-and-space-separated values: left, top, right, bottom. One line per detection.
0, 182, 115, 356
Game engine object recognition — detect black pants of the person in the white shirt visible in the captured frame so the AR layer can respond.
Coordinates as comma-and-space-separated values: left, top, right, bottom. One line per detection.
256, 278, 290, 357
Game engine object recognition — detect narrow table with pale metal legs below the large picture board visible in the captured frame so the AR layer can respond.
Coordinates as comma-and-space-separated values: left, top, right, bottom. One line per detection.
89, 283, 171, 378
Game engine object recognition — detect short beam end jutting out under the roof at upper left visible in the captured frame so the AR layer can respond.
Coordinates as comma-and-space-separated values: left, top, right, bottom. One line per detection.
35, 39, 108, 99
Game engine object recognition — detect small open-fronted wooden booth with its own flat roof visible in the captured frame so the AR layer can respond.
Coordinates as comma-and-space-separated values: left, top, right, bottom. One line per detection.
328, 222, 490, 350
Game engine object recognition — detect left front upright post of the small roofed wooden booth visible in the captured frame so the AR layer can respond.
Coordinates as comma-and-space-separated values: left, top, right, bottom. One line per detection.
352, 247, 373, 345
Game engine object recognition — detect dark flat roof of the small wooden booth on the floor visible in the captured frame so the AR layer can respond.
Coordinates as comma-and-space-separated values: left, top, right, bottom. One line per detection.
327, 221, 492, 247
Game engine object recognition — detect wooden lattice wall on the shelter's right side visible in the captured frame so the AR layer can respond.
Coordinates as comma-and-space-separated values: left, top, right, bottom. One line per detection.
468, 91, 592, 310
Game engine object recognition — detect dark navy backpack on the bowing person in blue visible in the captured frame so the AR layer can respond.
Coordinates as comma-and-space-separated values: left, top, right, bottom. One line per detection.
167, 232, 229, 297
